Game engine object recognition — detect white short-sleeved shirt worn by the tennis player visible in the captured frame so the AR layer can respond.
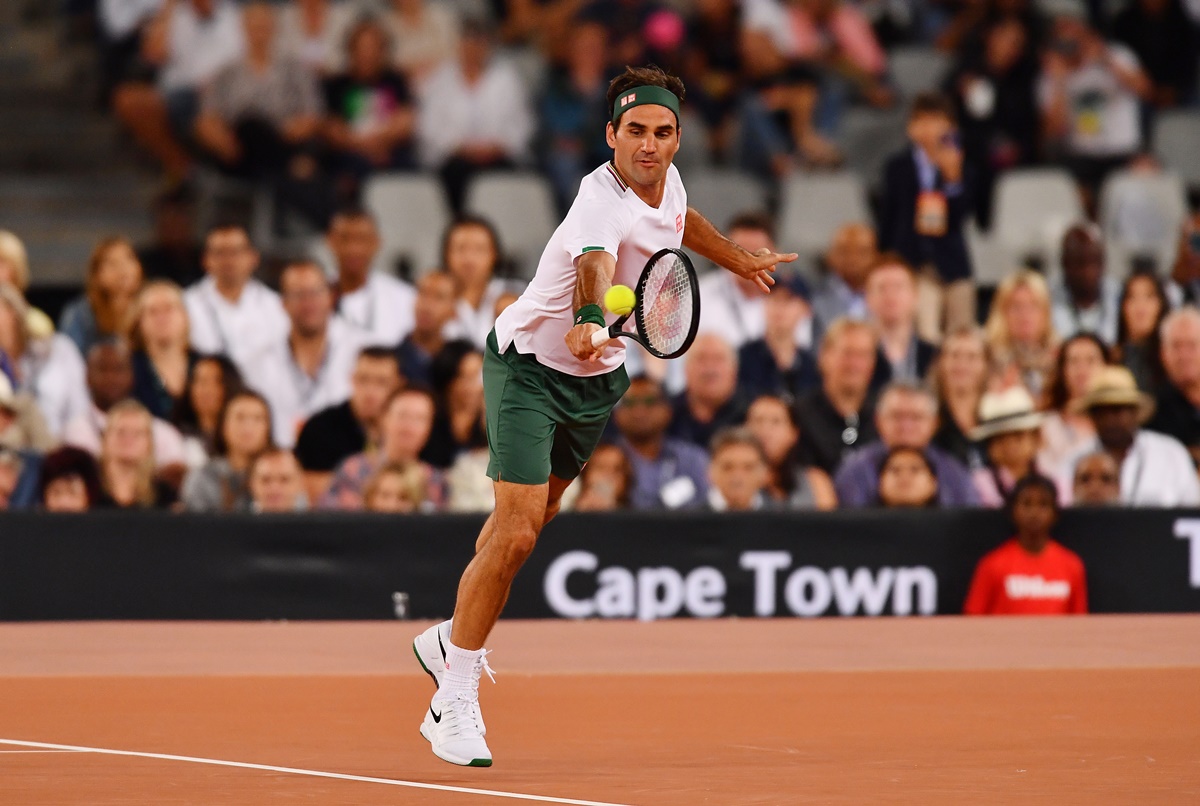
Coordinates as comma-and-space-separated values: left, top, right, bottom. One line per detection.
496, 162, 688, 378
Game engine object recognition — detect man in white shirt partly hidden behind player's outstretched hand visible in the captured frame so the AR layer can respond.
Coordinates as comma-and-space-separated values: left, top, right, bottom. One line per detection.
700, 212, 812, 349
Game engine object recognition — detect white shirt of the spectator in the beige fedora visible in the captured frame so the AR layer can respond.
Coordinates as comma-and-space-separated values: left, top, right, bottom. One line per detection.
1070, 431, 1200, 506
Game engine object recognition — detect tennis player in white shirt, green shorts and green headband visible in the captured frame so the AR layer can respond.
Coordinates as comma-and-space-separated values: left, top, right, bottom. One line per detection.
413, 67, 797, 766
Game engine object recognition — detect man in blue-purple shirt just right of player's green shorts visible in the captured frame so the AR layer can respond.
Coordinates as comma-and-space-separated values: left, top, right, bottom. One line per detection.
614, 375, 708, 510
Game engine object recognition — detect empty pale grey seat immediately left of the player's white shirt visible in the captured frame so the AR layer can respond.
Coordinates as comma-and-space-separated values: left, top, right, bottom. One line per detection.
463, 172, 558, 279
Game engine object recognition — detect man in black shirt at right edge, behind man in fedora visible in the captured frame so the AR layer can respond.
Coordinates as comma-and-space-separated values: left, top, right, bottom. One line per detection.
1146, 306, 1200, 458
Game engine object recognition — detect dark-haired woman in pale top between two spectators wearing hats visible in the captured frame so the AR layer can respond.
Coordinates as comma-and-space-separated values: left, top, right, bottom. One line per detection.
1038, 333, 1111, 477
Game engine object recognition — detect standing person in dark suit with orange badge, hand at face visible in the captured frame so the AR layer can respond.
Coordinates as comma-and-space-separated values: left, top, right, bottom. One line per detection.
880, 92, 976, 342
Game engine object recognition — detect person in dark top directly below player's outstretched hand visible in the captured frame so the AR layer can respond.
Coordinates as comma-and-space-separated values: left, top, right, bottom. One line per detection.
738, 275, 821, 401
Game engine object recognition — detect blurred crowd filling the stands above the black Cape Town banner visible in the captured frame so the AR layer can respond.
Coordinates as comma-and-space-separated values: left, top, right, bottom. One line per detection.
0, 0, 1200, 512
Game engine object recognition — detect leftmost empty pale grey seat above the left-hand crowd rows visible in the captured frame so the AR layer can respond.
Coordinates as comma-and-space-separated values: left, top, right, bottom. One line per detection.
362, 174, 450, 278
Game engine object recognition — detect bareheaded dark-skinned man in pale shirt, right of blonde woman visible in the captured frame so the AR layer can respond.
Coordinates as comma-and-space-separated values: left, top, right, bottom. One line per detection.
1050, 223, 1121, 344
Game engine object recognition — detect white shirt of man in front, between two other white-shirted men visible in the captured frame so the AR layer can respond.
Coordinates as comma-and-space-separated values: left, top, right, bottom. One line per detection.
246, 317, 364, 449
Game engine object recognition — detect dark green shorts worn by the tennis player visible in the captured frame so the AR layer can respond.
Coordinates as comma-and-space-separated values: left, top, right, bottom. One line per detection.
484, 330, 629, 485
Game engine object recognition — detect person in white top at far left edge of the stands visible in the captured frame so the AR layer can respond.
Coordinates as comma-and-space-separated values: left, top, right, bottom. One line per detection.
0, 283, 91, 438
